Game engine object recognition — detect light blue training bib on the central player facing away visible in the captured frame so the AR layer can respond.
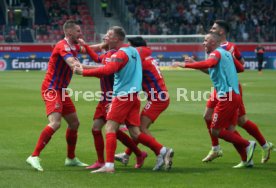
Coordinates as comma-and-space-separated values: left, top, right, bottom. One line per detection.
113, 46, 142, 96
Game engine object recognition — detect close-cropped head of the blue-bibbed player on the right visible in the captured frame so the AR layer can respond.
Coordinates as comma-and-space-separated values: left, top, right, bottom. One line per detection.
203, 32, 221, 53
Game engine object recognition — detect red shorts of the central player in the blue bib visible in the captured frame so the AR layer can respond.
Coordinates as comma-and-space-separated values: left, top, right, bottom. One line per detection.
106, 93, 140, 126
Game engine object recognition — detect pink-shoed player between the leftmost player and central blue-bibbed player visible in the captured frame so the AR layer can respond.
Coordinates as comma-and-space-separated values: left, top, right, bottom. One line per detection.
80, 36, 147, 169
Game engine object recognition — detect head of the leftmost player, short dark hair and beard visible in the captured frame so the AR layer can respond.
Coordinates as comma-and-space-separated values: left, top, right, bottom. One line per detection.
63, 20, 82, 43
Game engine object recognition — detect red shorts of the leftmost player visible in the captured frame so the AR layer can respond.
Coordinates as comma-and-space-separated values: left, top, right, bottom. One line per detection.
41, 89, 76, 116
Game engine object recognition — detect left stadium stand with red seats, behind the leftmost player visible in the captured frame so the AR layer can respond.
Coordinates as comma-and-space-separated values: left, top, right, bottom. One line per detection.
0, 0, 94, 43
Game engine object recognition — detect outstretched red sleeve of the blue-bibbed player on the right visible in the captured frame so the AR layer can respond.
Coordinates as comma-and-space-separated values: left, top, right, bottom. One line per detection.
185, 51, 221, 69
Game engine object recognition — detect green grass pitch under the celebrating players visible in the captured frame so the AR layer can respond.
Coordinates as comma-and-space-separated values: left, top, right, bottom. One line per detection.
0, 70, 276, 188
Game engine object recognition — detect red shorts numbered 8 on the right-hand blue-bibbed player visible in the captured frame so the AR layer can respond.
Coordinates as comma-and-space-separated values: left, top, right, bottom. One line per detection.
211, 92, 241, 129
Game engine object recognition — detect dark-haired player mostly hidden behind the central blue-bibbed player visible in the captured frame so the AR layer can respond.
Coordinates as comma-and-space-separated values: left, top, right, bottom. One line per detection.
115, 37, 170, 165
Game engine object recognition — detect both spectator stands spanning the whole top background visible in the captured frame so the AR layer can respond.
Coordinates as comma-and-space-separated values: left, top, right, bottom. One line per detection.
0, 0, 276, 43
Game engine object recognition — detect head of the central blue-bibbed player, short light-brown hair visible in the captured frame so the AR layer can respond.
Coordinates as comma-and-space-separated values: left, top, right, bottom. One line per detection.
106, 26, 126, 49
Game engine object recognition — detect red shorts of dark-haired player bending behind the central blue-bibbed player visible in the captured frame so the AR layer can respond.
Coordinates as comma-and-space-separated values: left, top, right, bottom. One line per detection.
141, 98, 170, 122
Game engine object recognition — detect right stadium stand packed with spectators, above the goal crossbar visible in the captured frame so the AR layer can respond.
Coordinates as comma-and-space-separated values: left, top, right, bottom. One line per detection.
126, 0, 276, 42
